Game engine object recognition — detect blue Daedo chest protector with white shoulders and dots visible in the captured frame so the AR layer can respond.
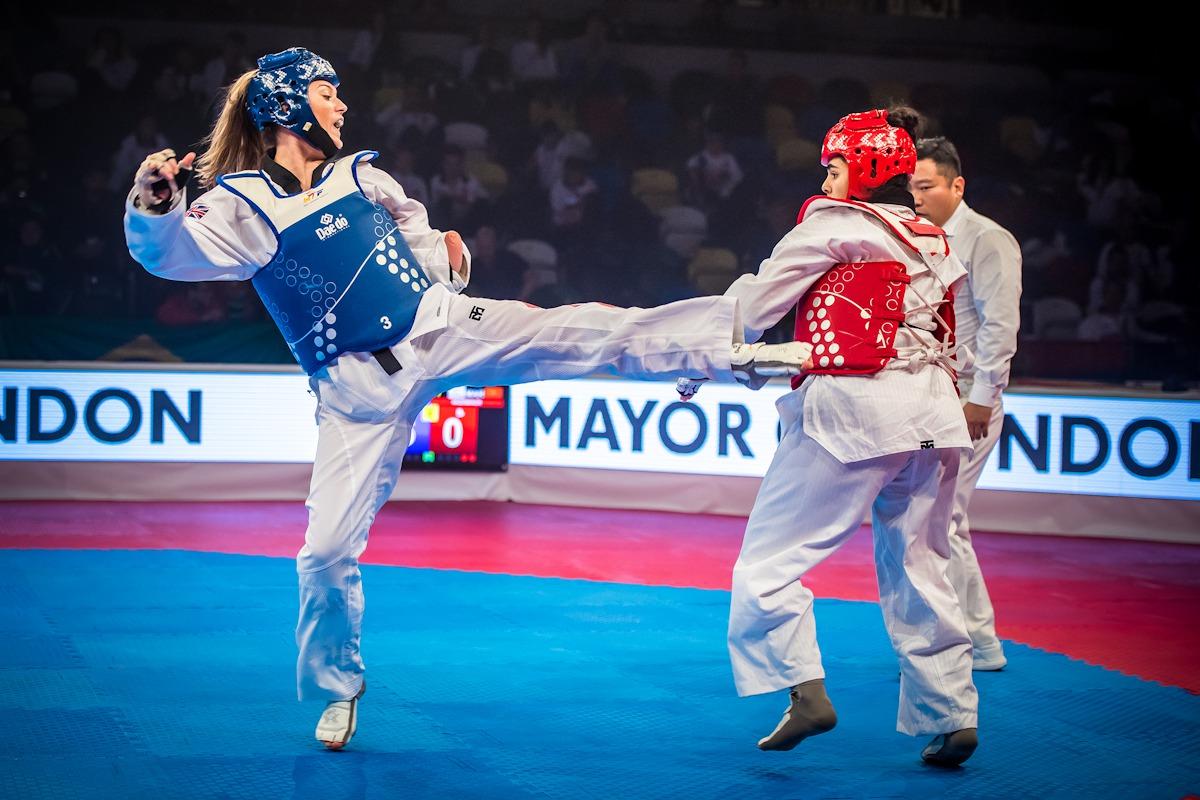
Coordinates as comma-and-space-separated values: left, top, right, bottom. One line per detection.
217, 151, 430, 375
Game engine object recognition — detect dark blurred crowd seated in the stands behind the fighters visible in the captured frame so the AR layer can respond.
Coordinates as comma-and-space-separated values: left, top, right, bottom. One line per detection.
0, 4, 1200, 375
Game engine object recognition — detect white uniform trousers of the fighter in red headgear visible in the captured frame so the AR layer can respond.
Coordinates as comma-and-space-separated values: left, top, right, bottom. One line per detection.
728, 387, 978, 735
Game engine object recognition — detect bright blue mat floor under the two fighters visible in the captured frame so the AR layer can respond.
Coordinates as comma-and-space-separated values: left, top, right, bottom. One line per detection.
0, 551, 1200, 800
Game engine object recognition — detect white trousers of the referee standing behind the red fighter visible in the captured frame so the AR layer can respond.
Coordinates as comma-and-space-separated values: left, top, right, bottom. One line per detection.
947, 383, 1004, 658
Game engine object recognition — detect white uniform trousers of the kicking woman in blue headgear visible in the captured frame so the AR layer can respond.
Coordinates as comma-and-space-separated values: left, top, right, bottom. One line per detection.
296, 285, 742, 702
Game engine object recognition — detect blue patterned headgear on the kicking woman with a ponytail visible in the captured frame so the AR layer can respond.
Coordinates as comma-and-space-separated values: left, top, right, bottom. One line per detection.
246, 47, 338, 158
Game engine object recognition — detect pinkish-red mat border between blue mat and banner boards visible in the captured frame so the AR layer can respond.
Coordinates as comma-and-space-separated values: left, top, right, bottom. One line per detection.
0, 503, 1200, 692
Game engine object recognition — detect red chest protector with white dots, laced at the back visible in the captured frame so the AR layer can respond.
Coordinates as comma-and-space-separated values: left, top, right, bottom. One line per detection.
792, 197, 954, 387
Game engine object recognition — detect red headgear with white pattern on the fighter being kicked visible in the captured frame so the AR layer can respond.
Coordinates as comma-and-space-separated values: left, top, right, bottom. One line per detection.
821, 108, 917, 200
